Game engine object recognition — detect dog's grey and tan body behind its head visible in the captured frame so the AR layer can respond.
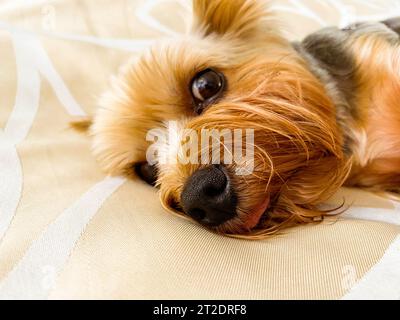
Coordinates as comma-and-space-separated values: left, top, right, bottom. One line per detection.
295, 18, 400, 192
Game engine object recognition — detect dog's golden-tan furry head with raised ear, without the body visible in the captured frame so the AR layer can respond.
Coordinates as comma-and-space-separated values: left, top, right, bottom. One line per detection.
92, 0, 347, 237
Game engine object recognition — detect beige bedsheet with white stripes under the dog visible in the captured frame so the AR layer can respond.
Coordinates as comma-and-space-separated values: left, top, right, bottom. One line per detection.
0, 0, 400, 299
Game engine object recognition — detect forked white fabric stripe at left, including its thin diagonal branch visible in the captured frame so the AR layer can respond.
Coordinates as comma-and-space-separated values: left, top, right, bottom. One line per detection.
0, 33, 85, 240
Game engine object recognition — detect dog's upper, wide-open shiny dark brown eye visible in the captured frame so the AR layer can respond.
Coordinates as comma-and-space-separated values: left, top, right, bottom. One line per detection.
191, 69, 225, 114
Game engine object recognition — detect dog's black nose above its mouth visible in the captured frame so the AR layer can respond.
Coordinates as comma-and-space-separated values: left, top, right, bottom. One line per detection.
181, 165, 237, 227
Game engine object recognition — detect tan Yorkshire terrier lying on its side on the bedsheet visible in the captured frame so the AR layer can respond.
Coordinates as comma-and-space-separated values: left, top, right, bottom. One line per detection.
75, 0, 400, 239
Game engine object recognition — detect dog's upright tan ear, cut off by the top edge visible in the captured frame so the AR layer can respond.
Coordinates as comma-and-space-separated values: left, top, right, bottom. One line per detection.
193, 0, 272, 39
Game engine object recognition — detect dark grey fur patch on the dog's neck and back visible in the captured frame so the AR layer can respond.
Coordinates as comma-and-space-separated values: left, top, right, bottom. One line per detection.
293, 18, 400, 154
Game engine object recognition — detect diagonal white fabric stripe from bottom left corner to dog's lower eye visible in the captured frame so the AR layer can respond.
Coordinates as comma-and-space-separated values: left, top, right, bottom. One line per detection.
0, 177, 125, 299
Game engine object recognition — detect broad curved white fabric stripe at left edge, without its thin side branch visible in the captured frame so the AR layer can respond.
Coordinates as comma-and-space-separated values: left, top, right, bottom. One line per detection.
0, 36, 40, 240
